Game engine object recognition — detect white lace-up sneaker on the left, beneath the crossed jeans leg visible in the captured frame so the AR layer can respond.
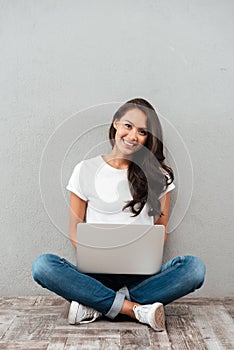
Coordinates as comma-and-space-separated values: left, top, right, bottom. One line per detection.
68, 301, 102, 324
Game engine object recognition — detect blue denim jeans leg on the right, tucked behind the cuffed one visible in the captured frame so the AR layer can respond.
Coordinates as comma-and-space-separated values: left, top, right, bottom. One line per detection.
128, 256, 206, 305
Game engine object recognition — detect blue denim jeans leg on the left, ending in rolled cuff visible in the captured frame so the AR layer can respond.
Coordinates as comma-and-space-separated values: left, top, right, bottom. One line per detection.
32, 254, 125, 318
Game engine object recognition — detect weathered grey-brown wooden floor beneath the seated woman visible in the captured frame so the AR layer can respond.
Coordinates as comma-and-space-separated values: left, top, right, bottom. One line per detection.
0, 297, 234, 350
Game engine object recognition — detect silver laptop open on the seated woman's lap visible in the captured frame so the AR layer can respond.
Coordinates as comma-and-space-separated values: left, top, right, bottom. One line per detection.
77, 223, 165, 275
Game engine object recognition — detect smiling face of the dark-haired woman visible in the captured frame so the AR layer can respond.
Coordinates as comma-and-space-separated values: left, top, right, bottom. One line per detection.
114, 109, 147, 156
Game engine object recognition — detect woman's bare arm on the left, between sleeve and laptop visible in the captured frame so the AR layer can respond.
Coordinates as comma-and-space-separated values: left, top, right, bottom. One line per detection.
69, 192, 87, 248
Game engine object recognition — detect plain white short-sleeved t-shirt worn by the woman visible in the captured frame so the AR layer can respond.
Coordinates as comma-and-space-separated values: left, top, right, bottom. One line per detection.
66, 155, 175, 225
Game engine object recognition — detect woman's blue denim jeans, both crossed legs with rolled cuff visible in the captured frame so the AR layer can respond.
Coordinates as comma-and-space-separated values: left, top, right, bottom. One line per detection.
32, 254, 206, 319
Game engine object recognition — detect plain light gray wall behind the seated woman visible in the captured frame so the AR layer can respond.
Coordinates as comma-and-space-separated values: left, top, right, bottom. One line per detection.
0, 0, 234, 297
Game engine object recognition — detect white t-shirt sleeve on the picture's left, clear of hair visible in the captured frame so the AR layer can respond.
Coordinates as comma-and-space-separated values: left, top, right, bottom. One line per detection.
66, 162, 88, 201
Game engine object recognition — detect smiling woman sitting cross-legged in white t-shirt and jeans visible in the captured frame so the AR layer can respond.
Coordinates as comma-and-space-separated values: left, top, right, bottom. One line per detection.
33, 98, 205, 331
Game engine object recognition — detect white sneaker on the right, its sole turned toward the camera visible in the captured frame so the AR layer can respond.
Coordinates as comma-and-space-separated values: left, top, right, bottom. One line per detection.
133, 303, 165, 331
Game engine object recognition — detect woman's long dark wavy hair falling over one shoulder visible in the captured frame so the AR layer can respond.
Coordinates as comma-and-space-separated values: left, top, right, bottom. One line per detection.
109, 98, 174, 216
